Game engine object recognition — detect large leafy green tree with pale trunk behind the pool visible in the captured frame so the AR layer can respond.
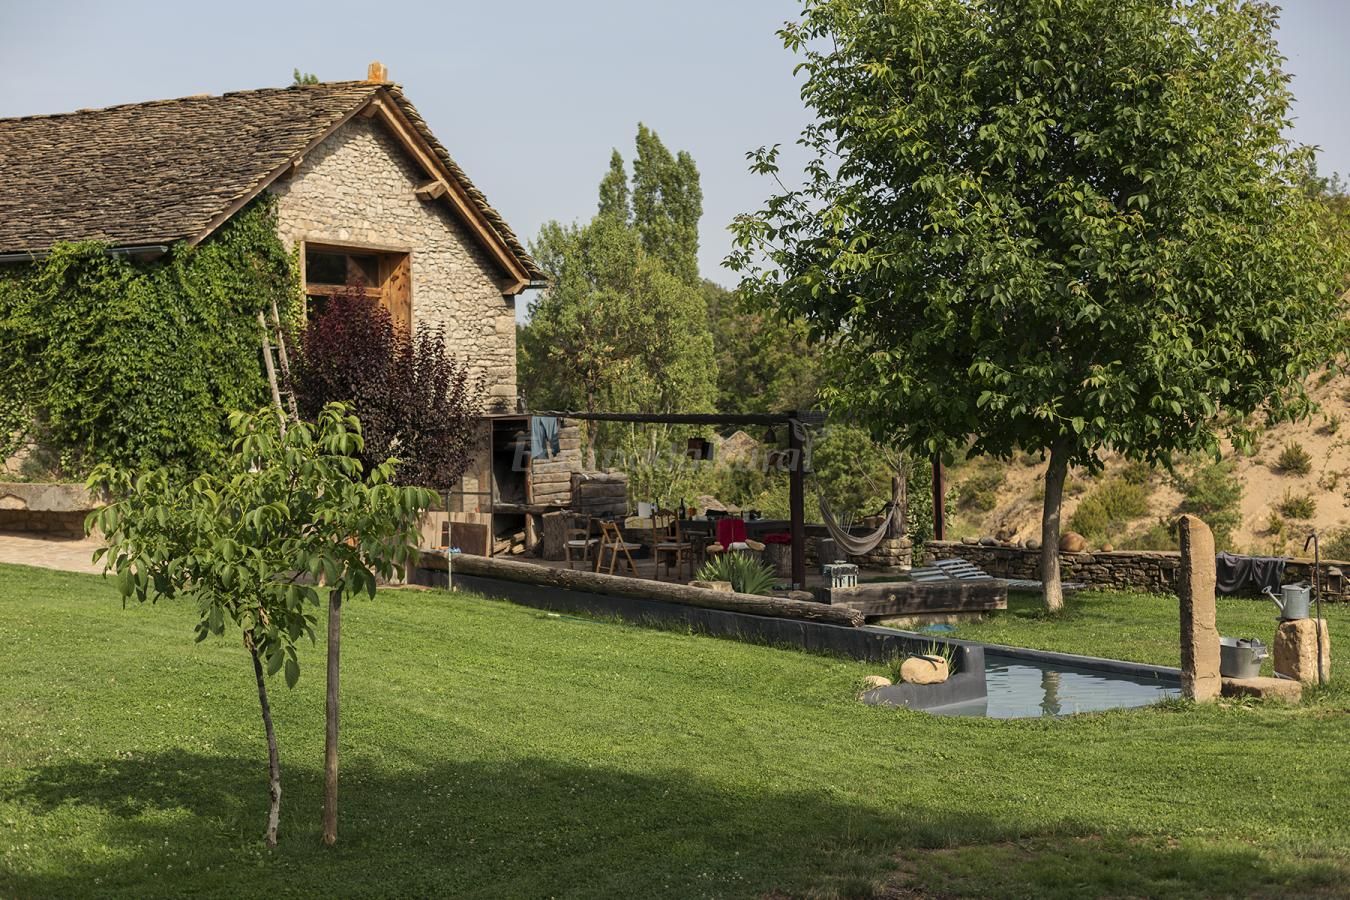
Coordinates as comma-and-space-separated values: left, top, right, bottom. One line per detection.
730, 0, 1346, 609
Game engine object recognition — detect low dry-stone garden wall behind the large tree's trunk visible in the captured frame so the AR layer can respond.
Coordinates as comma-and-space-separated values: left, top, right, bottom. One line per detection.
923, 541, 1350, 602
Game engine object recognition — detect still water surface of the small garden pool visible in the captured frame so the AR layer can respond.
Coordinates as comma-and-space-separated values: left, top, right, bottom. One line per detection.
932, 653, 1181, 719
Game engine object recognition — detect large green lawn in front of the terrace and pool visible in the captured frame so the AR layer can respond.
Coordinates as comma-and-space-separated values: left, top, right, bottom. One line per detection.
0, 567, 1350, 897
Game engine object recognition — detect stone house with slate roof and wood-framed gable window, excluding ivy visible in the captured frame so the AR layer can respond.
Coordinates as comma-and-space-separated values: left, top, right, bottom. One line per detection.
0, 63, 544, 412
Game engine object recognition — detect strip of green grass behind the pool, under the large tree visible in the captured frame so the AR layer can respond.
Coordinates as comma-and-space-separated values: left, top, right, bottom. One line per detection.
952, 591, 1350, 671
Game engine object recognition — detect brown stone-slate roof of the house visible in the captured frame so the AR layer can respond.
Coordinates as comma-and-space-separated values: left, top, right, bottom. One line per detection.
0, 81, 544, 279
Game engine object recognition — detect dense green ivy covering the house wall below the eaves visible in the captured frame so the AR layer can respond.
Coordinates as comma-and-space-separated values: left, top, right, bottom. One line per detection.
0, 196, 300, 478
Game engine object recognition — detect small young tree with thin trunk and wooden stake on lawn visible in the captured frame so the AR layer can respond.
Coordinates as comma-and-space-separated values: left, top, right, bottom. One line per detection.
88, 403, 433, 846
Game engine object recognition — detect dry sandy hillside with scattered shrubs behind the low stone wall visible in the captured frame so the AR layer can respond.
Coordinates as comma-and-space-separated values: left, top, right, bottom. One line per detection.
950, 376, 1350, 553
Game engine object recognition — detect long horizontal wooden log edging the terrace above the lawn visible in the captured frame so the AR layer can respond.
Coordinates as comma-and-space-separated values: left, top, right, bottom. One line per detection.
421, 553, 864, 627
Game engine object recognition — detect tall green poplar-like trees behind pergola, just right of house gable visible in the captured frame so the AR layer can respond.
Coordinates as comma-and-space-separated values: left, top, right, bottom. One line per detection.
518, 125, 717, 472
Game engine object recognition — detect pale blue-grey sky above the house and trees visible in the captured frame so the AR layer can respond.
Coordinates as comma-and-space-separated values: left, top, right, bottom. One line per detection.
0, 0, 1350, 285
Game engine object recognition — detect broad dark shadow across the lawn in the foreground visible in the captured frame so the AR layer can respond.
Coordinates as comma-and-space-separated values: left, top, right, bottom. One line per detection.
0, 752, 1346, 897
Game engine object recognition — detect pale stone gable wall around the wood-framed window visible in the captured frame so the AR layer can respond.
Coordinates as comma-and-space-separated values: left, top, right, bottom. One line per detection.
271, 117, 516, 410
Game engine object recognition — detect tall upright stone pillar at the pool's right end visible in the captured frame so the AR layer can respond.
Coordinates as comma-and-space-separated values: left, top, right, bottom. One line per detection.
1177, 515, 1222, 703
